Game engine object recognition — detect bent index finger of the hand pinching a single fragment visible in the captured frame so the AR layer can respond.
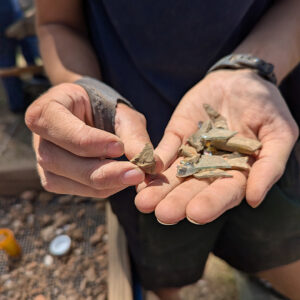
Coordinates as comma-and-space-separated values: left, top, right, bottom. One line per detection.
25, 94, 124, 157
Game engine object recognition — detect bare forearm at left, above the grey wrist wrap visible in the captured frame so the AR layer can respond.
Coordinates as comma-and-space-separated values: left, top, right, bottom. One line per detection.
36, 0, 101, 84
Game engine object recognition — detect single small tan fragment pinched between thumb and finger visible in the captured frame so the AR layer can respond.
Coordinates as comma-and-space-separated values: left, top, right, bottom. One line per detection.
130, 143, 156, 174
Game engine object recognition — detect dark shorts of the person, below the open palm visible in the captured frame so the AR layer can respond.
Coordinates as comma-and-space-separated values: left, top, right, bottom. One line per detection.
109, 142, 300, 289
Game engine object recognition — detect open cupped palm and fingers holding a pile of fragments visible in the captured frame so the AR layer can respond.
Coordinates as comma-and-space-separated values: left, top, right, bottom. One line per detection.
135, 70, 298, 224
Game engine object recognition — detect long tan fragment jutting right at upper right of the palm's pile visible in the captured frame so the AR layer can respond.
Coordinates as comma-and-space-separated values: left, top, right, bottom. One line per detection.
211, 136, 262, 155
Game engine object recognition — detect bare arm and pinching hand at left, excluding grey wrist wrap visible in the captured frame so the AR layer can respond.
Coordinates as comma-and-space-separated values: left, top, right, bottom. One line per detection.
25, 0, 162, 198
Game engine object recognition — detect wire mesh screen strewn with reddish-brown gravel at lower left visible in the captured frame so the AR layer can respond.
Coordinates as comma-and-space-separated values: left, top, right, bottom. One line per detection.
0, 192, 107, 300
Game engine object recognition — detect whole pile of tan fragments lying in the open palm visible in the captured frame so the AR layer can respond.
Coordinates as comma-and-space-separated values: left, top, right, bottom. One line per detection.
177, 104, 261, 179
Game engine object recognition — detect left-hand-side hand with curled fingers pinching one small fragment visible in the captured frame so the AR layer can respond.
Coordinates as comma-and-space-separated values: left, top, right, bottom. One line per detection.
25, 83, 162, 198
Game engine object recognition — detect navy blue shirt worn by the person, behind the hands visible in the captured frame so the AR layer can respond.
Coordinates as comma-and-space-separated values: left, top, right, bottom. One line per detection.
84, 0, 300, 257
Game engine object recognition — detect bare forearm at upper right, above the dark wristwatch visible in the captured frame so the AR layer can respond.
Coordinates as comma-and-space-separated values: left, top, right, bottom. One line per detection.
234, 0, 300, 82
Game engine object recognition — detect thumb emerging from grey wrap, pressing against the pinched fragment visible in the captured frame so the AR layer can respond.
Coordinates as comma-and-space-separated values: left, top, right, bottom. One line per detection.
115, 103, 163, 173
